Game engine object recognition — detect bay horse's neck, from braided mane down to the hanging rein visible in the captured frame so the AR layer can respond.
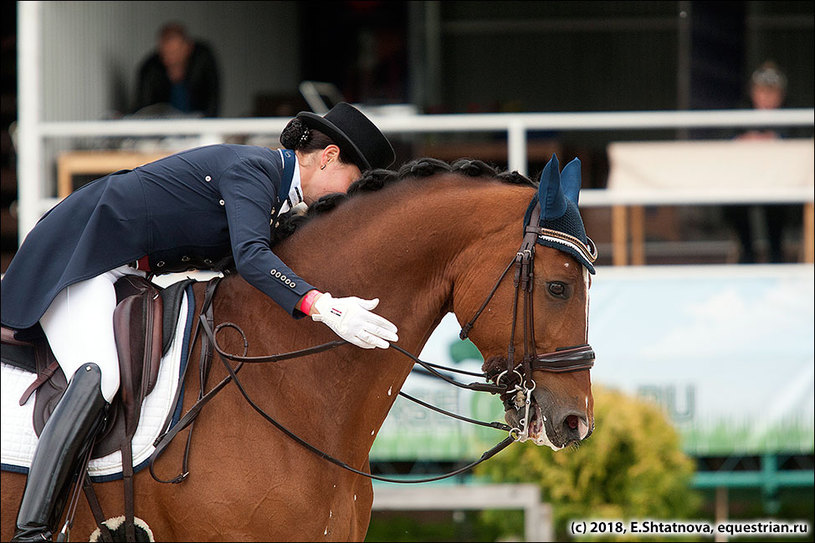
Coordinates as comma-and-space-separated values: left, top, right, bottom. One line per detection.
219, 179, 531, 459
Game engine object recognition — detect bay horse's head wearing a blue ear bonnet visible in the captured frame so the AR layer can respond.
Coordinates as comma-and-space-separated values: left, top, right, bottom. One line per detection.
456, 157, 596, 450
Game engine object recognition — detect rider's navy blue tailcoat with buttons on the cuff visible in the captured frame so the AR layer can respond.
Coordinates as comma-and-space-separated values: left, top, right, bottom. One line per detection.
2, 144, 314, 330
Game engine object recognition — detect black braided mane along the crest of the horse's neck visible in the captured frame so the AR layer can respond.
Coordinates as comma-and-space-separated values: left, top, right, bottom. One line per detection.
271, 158, 537, 246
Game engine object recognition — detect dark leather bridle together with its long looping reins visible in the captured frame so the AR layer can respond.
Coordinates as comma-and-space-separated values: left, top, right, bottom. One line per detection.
150, 200, 595, 483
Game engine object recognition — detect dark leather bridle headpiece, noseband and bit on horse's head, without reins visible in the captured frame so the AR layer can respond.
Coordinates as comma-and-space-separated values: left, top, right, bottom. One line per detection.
459, 204, 595, 441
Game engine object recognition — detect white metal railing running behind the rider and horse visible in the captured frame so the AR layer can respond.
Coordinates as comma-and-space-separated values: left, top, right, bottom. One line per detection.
18, 107, 815, 240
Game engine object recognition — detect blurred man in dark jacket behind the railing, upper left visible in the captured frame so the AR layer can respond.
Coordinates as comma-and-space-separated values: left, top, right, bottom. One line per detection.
135, 22, 220, 117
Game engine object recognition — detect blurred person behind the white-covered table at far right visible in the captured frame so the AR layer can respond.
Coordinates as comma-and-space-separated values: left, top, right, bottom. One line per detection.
725, 61, 800, 264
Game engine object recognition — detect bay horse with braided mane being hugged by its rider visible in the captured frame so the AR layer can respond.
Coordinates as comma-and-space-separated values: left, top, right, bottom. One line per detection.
2, 159, 594, 541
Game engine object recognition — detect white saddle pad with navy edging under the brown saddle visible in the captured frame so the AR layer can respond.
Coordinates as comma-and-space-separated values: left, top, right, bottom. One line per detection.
0, 292, 192, 481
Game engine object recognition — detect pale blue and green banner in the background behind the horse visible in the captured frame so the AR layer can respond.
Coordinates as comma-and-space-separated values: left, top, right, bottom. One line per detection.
371, 264, 815, 460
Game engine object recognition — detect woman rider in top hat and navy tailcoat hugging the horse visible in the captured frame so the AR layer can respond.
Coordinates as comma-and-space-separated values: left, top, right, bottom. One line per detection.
2, 103, 398, 541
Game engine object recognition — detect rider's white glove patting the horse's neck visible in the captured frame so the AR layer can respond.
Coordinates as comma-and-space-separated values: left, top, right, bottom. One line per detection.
311, 292, 399, 349
